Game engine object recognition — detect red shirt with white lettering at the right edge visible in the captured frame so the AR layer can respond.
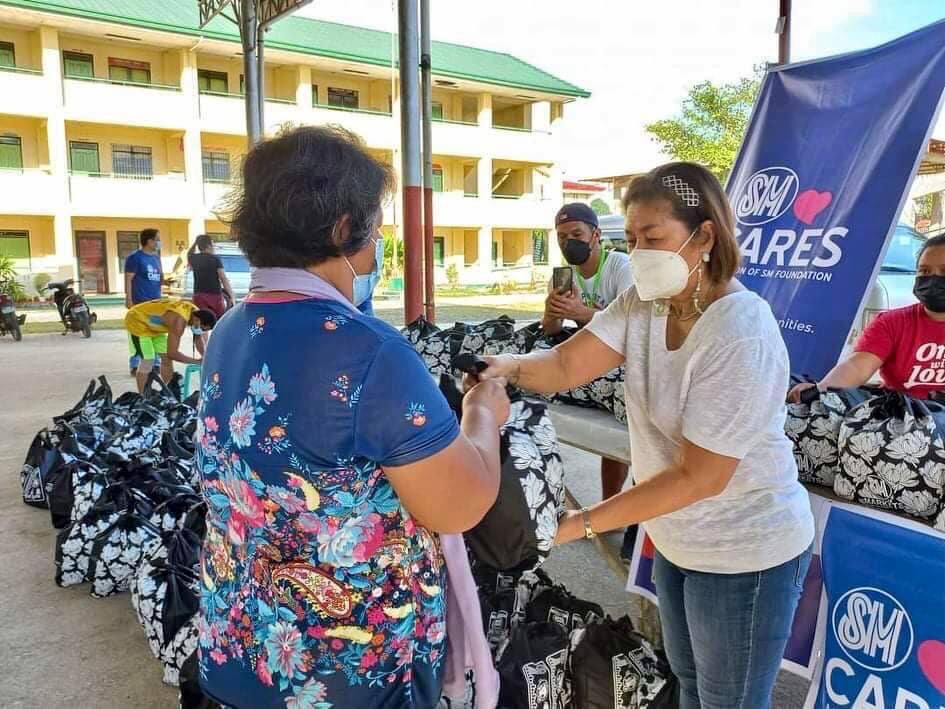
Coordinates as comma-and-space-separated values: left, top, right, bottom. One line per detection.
856, 304, 945, 399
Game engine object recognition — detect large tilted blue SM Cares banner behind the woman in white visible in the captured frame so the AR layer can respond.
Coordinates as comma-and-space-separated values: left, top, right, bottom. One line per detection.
728, 21, 945, 378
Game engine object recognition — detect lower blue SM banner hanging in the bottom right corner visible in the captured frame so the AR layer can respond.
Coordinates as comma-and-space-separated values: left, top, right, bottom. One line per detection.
807, 505, 945, 709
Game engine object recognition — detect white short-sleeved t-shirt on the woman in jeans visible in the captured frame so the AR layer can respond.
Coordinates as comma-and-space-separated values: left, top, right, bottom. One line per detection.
587, 288, 814, 573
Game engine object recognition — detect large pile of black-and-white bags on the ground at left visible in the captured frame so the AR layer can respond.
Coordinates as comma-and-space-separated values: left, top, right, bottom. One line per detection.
20, 376, 206, 685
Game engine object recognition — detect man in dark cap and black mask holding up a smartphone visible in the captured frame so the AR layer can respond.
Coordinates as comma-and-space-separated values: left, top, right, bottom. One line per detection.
541, 202, 634, 557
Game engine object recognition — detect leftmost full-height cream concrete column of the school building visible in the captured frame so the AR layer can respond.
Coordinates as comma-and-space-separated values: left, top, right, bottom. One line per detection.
39, 27, 76, 278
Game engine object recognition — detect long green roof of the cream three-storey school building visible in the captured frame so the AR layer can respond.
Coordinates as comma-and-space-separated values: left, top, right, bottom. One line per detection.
0, 0, 590, 98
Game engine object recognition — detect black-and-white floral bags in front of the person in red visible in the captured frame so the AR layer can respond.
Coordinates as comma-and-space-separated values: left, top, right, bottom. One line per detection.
785, 387, 945, 529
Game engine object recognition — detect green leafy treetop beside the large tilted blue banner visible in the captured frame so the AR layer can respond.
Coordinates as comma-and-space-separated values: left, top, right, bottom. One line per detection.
646, 67, 762, 182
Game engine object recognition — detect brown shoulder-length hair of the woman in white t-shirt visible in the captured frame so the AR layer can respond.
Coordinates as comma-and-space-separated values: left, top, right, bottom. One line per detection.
623, 162, 742, 283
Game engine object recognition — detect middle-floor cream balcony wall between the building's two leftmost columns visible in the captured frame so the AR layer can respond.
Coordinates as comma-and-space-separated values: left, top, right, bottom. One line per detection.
69, 173, 196, 219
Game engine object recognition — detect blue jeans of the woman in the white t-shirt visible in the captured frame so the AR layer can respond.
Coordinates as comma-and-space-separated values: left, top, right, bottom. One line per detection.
653, 549, 811, 709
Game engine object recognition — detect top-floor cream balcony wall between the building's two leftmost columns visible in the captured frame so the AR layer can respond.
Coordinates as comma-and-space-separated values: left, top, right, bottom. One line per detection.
63, 77, 189, 129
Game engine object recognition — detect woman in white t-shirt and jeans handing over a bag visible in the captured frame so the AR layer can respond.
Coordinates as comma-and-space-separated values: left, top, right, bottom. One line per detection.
482, 163, 814, 709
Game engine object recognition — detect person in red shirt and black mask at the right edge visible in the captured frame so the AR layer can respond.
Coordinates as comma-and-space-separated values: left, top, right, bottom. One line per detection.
790, 236, 945, 402
